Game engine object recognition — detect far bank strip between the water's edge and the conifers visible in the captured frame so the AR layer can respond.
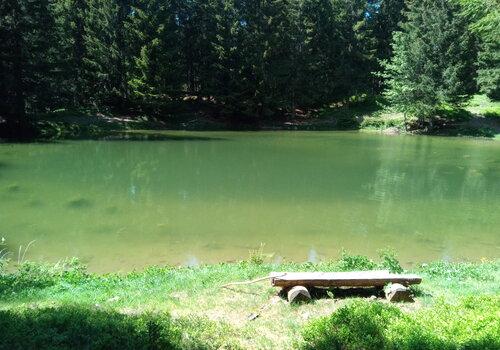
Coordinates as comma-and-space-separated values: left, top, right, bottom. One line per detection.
18, 95, 500, 139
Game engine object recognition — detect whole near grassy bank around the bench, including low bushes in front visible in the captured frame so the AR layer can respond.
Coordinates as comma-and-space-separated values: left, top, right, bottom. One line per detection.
0, 252, 500, 349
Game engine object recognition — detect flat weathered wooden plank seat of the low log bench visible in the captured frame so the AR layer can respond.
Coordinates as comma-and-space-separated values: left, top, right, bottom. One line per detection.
269, 271, 422, 288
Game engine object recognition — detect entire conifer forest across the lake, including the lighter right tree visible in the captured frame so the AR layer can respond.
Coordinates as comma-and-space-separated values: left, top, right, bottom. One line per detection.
0, 0, 500, 133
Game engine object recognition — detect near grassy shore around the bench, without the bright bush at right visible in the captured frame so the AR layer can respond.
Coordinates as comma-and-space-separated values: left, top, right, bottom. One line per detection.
0, 253, 500, 349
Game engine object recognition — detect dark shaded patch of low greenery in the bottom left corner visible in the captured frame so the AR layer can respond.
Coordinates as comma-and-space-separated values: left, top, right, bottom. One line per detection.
0, 306, 182, 349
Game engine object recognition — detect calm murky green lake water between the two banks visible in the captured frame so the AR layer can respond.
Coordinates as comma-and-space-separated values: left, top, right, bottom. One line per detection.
0, 132, 500, 272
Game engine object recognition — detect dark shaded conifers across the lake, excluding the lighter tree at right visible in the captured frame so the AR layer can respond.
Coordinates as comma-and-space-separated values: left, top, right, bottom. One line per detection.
0, 0, 498, 126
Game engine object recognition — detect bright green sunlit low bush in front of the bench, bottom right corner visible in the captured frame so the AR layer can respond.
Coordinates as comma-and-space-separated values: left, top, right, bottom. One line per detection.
303, 296, 500, 350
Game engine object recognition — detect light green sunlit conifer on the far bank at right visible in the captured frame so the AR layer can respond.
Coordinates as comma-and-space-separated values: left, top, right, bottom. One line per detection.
385, 0, 475, 118
